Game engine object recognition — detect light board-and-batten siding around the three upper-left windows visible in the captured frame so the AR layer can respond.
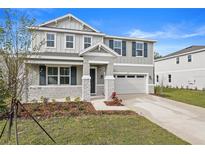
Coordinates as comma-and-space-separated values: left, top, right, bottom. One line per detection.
32, 31, 103, 53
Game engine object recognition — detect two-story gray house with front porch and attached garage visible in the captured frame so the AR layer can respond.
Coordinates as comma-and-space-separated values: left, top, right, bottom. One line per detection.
26, 14, 155, 101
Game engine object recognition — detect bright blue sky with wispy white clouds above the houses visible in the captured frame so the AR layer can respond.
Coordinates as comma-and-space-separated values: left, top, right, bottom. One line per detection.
0, 8, 205, 55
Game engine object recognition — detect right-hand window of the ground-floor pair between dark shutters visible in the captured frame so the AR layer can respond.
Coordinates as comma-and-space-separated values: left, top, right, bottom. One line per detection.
60, 67, 70, 84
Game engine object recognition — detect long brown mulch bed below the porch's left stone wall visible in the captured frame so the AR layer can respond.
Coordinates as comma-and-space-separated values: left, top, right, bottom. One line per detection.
16, 102, 136, 118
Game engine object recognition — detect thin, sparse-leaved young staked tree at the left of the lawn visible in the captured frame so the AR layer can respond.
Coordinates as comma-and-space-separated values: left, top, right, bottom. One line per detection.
0, 9, 46, 144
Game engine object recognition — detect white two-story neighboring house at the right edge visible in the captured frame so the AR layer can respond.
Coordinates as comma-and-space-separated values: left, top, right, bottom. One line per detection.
155, 46, 205, 90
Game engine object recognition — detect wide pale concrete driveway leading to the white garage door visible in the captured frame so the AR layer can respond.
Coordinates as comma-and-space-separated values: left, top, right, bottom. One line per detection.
120, 94, 205, 144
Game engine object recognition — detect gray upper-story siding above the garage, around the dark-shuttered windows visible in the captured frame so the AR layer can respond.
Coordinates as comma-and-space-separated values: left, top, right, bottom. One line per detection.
104, 38, 154, 64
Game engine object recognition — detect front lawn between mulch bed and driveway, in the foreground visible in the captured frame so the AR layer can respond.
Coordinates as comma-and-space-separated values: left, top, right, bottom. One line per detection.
0, 115, 188, 144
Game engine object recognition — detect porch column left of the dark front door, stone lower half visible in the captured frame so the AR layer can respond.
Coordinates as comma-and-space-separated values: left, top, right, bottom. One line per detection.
82, 60, 91, 101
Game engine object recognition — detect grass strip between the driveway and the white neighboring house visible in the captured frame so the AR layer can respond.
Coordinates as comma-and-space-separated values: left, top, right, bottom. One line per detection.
162, 88, 205, 107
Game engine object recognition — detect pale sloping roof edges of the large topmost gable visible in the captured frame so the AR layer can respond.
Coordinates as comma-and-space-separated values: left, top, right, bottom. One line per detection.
39, 13, 100, 33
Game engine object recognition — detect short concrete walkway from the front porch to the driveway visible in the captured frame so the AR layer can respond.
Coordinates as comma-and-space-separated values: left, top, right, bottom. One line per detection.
91, 99, 130, 111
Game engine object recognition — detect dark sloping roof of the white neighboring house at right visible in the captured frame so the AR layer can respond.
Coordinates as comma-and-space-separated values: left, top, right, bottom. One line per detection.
155, 45, 205, 61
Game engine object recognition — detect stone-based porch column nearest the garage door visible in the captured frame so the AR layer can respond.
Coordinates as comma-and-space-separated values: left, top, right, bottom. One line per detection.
104, 62, 115, 100
